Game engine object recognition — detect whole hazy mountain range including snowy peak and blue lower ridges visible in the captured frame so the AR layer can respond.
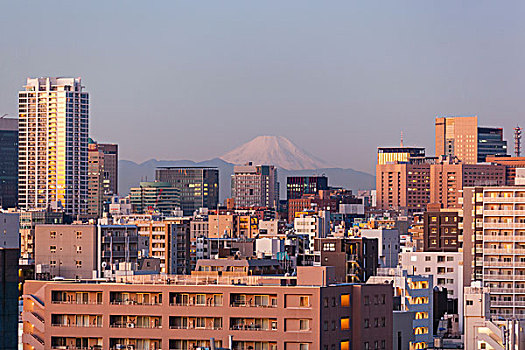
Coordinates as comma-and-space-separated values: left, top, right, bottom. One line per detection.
119, 136, 375, 201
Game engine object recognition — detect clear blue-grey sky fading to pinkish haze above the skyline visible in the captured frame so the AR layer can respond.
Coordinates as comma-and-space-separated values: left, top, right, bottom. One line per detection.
0, 0, 525, 172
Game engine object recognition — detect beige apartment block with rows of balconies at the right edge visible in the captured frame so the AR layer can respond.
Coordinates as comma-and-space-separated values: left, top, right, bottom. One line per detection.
463, 186, 525, 320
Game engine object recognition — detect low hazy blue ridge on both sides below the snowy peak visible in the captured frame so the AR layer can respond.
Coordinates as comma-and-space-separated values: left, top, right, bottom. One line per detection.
119, 158, 375, 202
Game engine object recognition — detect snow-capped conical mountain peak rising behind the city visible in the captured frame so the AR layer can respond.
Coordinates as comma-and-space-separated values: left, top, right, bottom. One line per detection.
219, 136, 330, 170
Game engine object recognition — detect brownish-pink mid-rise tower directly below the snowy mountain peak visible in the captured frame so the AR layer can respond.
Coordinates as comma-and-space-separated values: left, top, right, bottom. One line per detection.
231, 162, 279, 208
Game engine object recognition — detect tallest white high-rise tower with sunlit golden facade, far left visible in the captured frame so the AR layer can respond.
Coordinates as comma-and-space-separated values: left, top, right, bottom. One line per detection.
18, 77, 89, 215
